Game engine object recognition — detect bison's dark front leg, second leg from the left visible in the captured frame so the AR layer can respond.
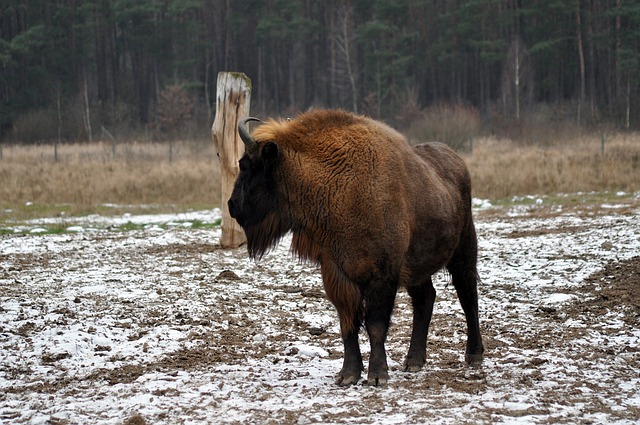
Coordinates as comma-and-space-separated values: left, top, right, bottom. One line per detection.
365, 284, 397, 385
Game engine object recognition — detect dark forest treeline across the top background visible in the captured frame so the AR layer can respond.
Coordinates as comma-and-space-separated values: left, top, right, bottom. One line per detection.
0, 0, 640, 140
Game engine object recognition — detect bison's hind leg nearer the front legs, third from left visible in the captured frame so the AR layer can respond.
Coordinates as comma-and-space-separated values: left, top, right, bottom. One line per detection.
404, 276, 436, 372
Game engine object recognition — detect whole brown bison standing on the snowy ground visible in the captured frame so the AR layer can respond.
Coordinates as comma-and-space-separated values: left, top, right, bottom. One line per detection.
228, 110, 484, 386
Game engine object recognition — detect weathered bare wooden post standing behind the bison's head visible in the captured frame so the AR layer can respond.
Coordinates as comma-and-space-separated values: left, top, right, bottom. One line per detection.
211, 72, 251, 248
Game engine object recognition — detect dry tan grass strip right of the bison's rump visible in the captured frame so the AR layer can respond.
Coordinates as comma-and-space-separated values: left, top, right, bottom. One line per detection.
465, 134, 640, 199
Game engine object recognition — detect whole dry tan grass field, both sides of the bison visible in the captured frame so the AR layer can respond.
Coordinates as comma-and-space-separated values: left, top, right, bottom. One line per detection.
0, 133, 640, 219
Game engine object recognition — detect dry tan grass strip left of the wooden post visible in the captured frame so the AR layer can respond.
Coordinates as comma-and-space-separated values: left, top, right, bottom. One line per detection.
0, 142, 220, 211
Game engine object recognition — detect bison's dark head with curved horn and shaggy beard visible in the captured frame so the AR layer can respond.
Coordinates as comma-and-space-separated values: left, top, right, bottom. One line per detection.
228, 118, 291, 258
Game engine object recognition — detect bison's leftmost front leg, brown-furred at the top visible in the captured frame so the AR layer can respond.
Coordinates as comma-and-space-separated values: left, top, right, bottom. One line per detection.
320, 259, 363, 386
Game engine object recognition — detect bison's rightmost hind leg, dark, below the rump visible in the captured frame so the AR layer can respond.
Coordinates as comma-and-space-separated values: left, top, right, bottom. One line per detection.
447, 220, 484, 366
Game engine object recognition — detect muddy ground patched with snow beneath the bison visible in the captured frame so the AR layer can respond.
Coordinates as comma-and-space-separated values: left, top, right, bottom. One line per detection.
0, 197, 640, 424
